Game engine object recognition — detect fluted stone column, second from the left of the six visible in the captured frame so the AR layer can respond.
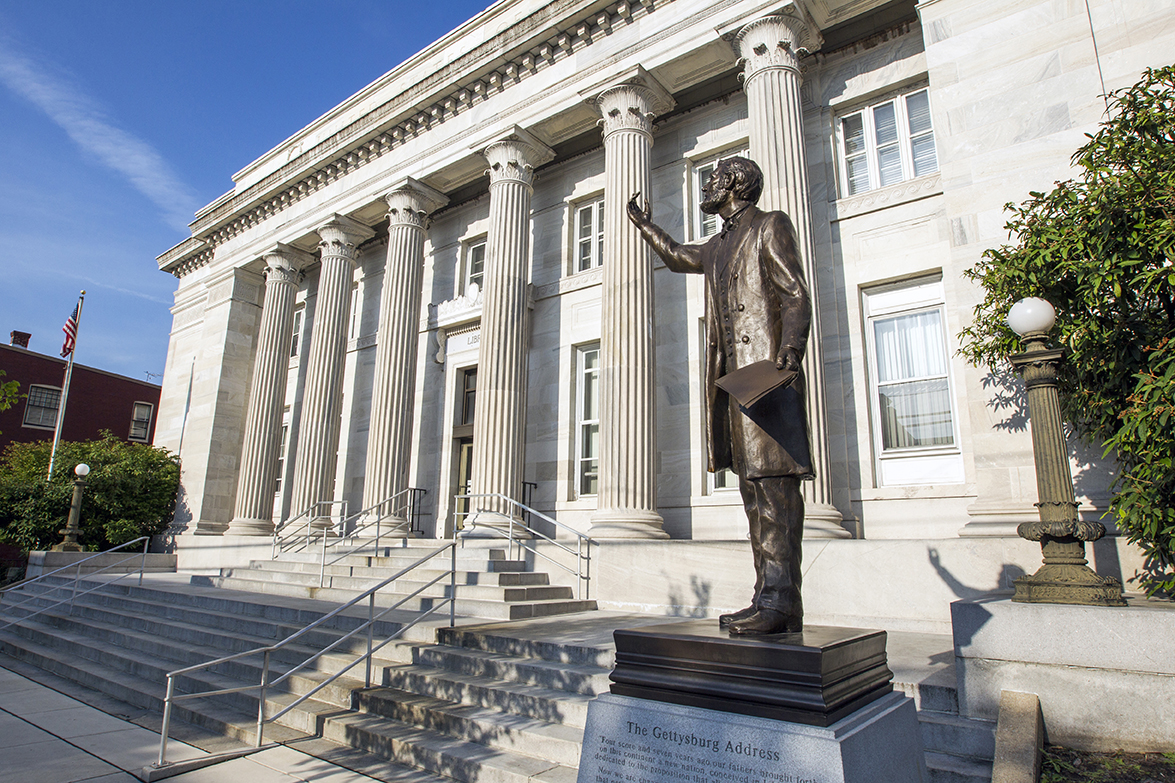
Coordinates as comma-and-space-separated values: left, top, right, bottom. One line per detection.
290, 215, 375, 516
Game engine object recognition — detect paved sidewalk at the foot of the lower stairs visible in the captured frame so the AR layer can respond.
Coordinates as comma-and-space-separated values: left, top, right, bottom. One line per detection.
0, 668, 377, 783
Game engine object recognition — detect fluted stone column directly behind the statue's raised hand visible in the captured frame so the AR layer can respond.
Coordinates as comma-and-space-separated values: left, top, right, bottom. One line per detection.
591, 67, 673, 538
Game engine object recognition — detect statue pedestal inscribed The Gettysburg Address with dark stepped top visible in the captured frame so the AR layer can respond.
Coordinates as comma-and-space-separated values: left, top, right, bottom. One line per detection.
578, 621, 928, 783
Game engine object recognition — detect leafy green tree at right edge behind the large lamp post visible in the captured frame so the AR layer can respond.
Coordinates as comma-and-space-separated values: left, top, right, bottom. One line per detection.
960, 66, 1175, 594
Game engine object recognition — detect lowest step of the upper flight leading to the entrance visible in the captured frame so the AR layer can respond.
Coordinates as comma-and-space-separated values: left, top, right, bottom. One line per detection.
198, 574, 596, 620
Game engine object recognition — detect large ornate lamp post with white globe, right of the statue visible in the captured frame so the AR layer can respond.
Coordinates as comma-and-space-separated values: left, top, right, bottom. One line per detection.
1008, 297, 1126, 607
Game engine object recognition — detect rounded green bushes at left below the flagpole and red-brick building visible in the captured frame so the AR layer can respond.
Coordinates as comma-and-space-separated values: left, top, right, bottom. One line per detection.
0, 433, 180, 551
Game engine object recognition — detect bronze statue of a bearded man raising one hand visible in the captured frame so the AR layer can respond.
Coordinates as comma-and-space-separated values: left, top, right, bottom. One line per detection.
627, 158, 814, 635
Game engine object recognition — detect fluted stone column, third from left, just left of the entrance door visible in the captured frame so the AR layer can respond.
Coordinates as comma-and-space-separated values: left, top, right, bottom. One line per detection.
363, 178, 449, 514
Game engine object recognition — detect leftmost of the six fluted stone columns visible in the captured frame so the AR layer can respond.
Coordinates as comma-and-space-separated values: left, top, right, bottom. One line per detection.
228, 243, 313, 536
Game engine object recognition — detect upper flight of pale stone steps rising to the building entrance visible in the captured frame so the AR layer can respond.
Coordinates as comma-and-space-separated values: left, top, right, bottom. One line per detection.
203, 538, 596, 620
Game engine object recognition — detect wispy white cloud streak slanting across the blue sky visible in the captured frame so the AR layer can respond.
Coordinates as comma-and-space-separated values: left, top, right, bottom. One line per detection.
0, 35, 200, 230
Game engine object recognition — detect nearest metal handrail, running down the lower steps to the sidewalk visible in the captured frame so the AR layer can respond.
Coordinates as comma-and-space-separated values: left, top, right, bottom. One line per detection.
152, 541, 457, 769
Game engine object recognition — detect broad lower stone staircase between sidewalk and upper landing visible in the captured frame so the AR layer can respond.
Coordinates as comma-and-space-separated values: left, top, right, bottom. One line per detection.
0, 571, 994, 783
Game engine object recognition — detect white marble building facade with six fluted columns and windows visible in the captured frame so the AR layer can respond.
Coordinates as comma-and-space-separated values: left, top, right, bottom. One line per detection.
155, 0, 1175, 625
